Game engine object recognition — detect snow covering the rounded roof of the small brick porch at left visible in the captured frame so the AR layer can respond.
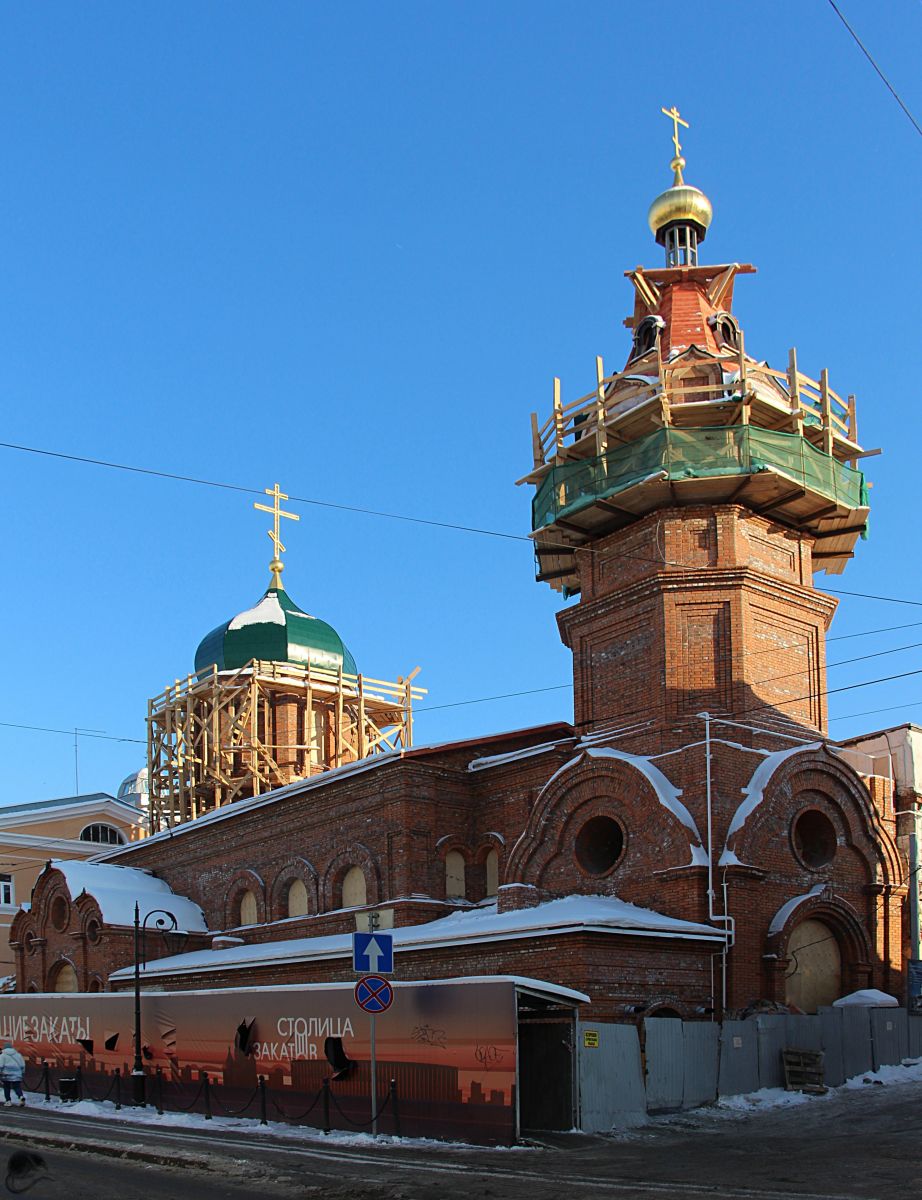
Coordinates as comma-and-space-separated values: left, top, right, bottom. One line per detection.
52, 858, 208, 934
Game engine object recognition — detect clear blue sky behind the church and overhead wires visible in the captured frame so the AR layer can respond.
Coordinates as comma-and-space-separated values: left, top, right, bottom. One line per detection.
0, 0, 922, 803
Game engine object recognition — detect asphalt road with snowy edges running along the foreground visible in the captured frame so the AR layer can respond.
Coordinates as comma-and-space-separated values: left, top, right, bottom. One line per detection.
0, 1084, 922, 1200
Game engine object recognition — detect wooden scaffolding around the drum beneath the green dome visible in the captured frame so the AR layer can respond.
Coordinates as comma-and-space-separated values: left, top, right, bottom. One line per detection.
148, 659, 425, 833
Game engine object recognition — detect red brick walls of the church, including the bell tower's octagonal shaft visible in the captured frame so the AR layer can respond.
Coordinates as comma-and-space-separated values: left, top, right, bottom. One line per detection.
12, 218, 906, 1020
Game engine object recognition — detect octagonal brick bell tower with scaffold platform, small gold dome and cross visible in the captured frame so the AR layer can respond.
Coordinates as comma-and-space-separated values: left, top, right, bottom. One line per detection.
520, 107, 869, 733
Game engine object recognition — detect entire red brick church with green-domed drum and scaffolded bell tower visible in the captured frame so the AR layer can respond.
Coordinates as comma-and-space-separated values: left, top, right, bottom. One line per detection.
11, 121, 917, 1021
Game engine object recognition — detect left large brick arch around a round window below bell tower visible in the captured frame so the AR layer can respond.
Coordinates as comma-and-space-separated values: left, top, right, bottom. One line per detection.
503, 751, 701, 894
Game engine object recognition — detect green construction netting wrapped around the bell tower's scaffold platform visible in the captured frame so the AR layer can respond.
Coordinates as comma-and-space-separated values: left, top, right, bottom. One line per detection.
532, 425, 868, 529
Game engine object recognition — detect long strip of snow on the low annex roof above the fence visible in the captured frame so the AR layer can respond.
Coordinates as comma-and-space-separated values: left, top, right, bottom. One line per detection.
110, 895, 725, 979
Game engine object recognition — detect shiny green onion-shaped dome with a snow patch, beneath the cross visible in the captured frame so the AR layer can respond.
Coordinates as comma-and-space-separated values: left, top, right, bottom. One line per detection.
196, 587, 358, 679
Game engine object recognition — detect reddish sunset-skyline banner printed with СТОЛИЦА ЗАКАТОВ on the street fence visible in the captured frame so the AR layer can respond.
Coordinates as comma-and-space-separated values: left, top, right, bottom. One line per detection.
0, 980, 516, 1142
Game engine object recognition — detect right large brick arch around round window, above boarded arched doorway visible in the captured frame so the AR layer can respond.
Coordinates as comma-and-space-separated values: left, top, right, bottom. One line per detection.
725, 746, 905, 888
